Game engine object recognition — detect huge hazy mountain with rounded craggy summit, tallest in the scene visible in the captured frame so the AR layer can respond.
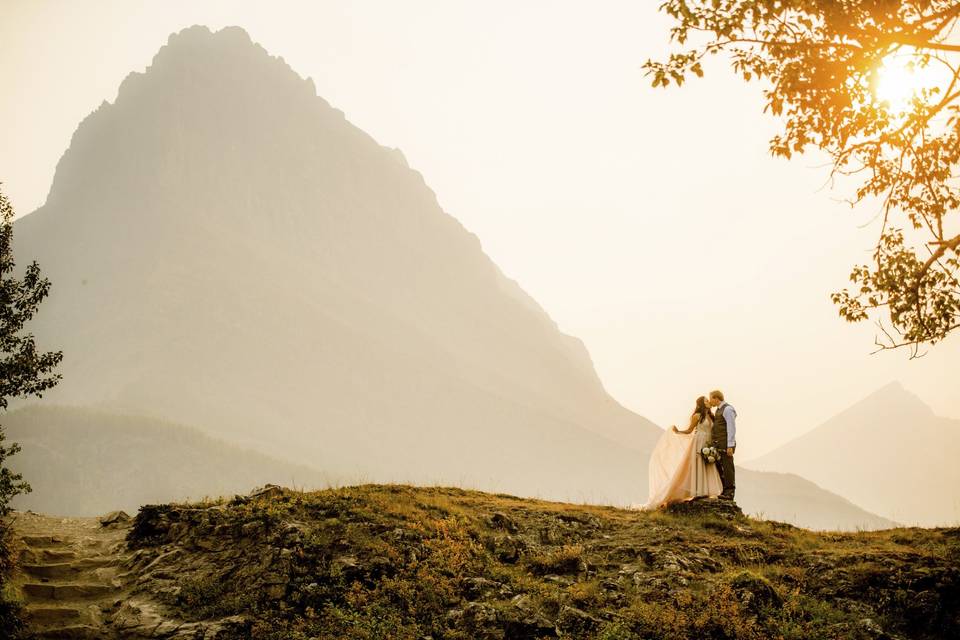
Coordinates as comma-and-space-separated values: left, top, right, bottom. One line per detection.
7, 27, 896, 526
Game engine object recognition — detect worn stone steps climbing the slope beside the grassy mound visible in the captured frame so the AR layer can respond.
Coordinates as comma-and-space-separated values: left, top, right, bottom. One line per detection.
14, 512, 126, 639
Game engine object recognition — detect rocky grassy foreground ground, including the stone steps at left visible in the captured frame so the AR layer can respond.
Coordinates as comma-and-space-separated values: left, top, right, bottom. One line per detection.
7, 485, 960, 640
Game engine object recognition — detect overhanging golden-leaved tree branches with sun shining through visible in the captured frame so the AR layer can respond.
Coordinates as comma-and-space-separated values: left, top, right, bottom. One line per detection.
645, 0, 960, 357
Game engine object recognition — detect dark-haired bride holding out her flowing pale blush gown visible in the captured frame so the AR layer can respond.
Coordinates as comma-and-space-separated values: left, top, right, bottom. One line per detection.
641, 396, 723, 509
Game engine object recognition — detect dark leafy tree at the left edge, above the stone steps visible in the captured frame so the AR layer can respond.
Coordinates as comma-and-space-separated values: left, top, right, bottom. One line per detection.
0, 185, 63, 516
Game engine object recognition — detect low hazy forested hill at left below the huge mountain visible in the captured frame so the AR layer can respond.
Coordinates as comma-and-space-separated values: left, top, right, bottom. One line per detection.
3, 406, 342, 516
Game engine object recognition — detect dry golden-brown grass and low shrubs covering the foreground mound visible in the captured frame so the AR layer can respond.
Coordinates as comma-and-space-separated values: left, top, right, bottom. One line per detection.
127, 485, 960, 640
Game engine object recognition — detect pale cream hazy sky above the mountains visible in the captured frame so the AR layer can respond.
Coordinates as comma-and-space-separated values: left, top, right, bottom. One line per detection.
0, 0, 960, 460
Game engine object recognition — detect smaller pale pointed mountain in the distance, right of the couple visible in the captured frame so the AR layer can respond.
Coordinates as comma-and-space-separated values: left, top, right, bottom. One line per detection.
746, 382, 960, 526
